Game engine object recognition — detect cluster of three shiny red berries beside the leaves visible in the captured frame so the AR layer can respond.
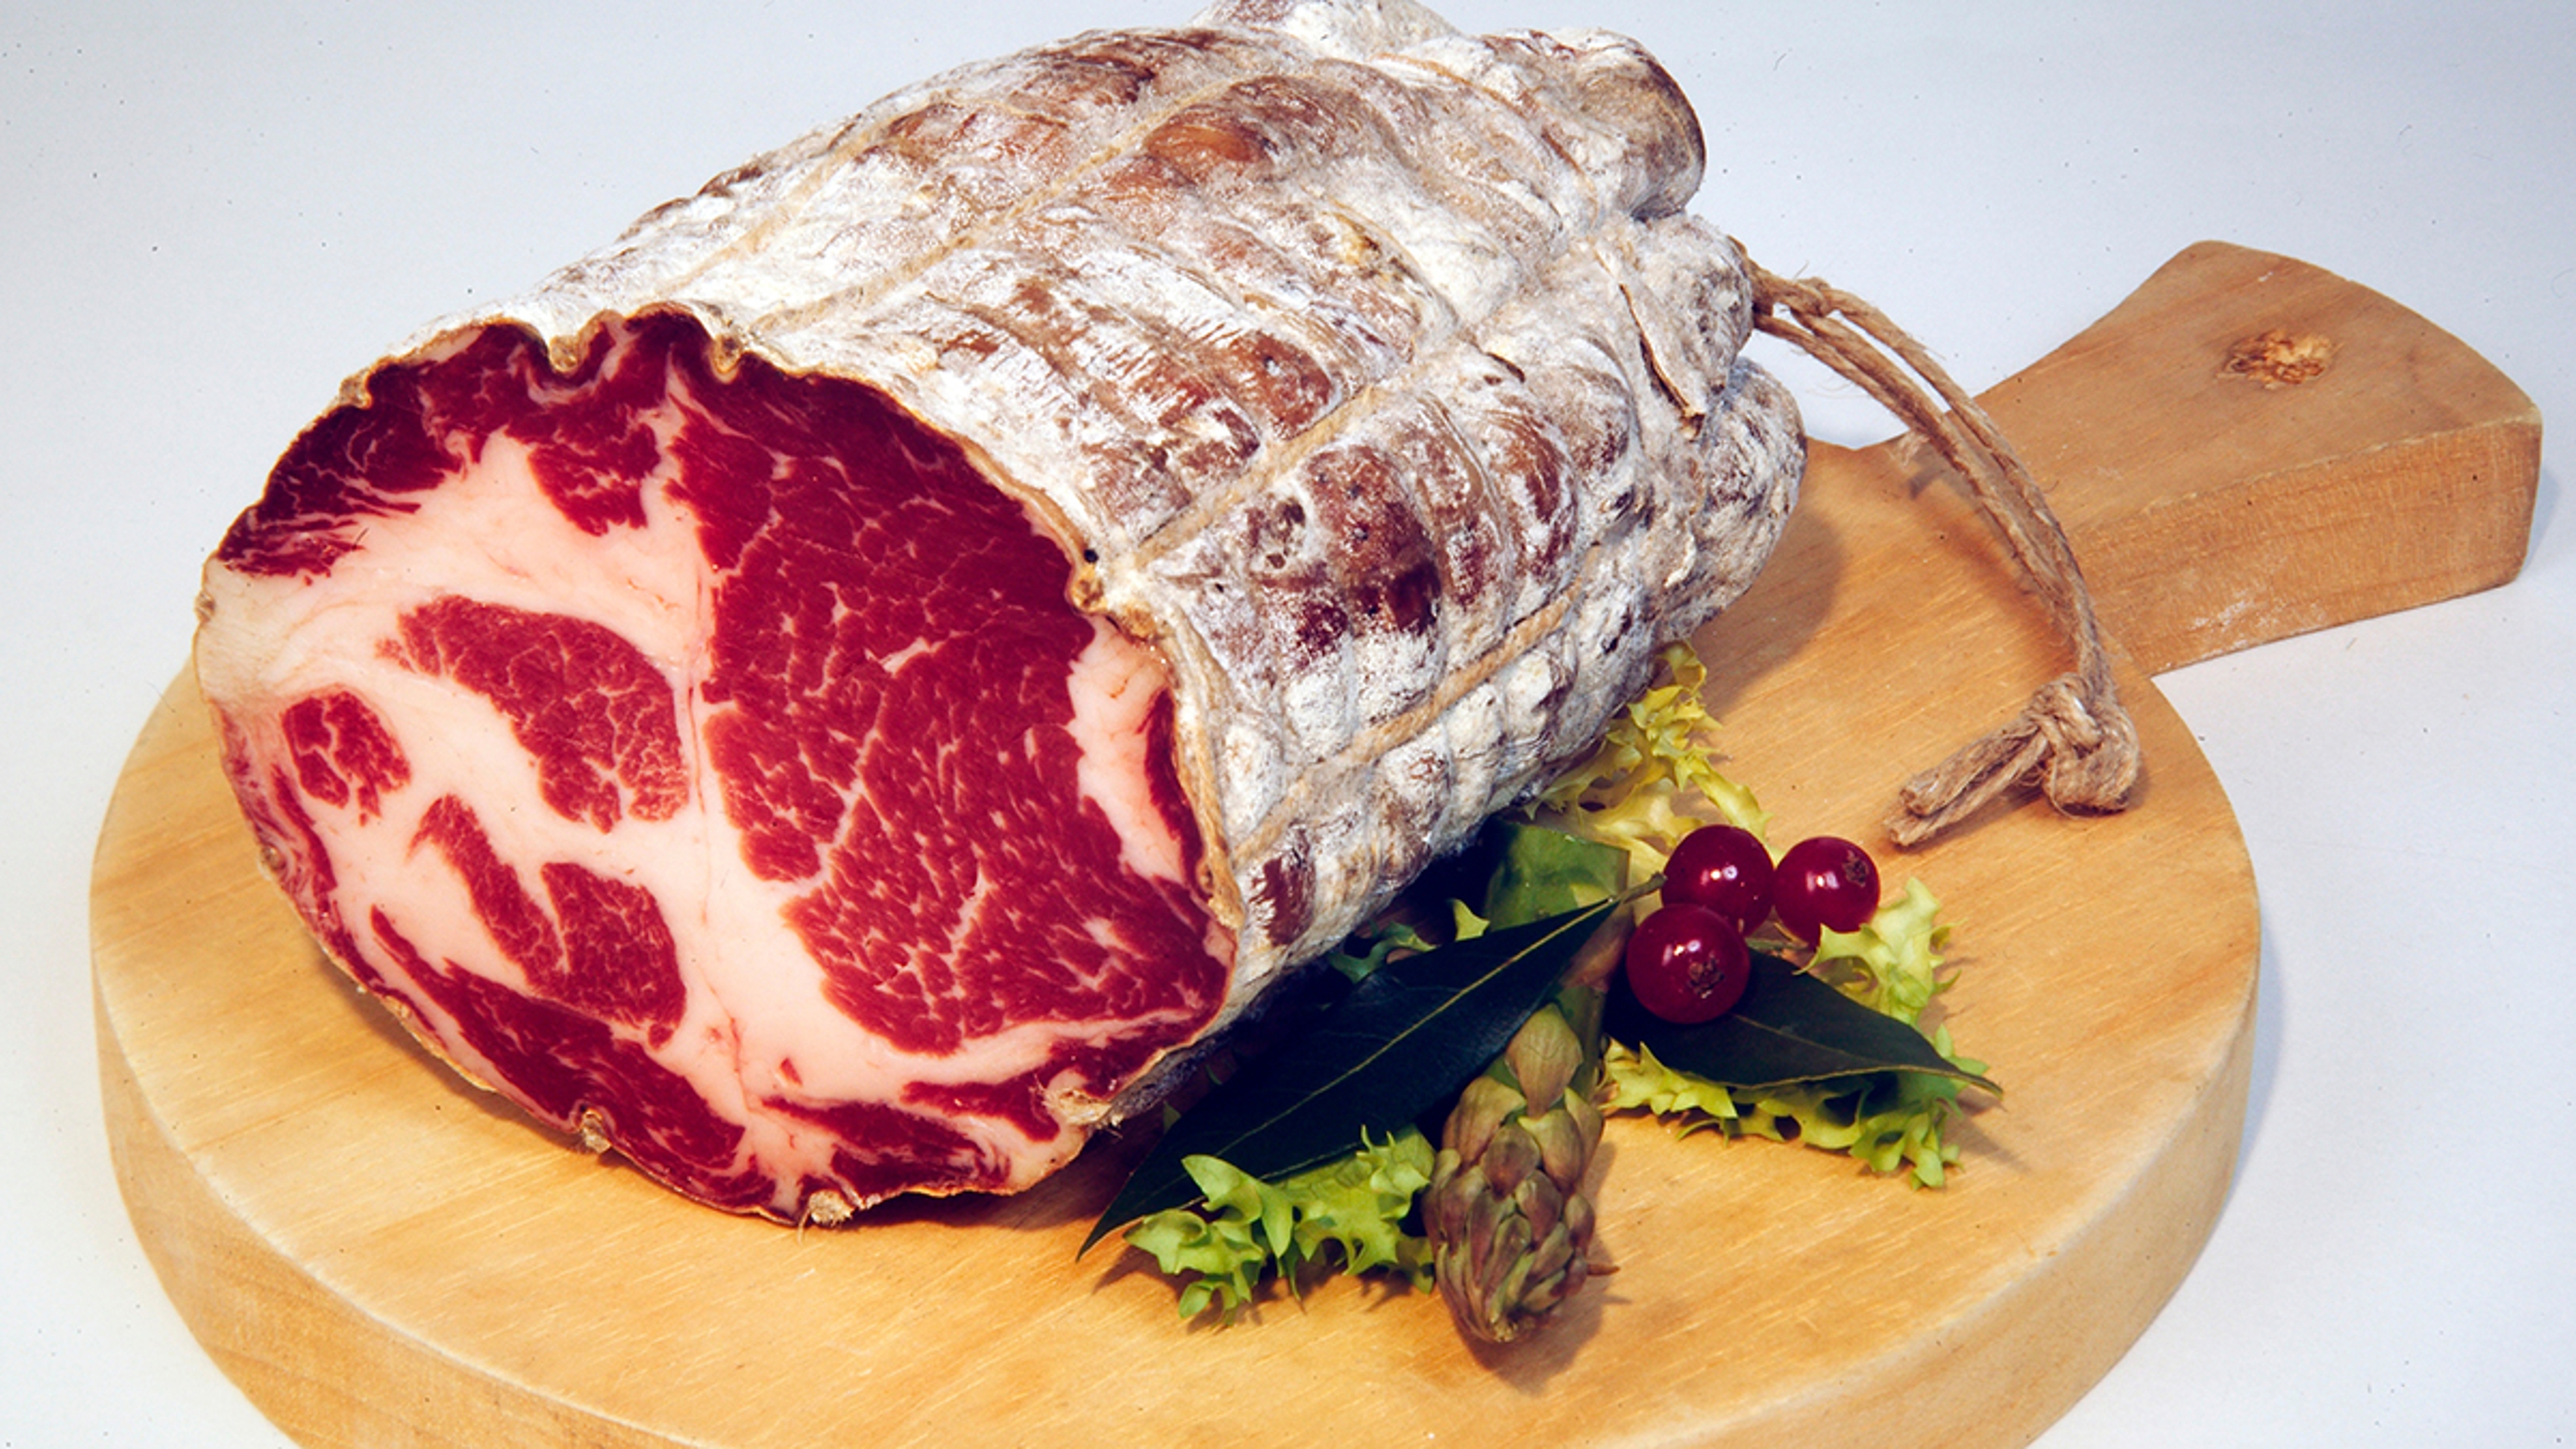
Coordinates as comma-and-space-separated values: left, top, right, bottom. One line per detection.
1628, 825, 1878, 1026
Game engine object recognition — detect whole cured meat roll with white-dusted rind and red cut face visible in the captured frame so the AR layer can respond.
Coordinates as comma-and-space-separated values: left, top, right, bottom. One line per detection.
196, 0, 1803, 1222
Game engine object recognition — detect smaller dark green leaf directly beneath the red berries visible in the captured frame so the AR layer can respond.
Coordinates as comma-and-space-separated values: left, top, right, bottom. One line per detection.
1602, 951, 2002, 1091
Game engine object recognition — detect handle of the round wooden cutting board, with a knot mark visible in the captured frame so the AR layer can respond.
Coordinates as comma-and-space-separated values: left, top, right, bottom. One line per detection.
1880, 242, 2540, 673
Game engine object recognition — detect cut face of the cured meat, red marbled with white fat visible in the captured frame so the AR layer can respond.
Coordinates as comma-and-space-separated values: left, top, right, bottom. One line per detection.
201, 315, 1234, 1217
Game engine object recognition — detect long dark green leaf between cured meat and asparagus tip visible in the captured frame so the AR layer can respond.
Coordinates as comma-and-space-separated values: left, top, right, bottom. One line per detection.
1082, 900, 1613, 1250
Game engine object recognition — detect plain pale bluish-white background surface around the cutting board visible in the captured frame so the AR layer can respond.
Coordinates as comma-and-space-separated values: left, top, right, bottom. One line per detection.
0, 0, 2576, 1449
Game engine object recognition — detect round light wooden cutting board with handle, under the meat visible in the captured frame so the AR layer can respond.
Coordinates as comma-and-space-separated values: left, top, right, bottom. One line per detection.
93, 245, 2540, 1449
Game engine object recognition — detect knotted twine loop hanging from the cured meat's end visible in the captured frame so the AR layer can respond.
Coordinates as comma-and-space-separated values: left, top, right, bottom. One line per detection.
1747, 245, 2141, 846
